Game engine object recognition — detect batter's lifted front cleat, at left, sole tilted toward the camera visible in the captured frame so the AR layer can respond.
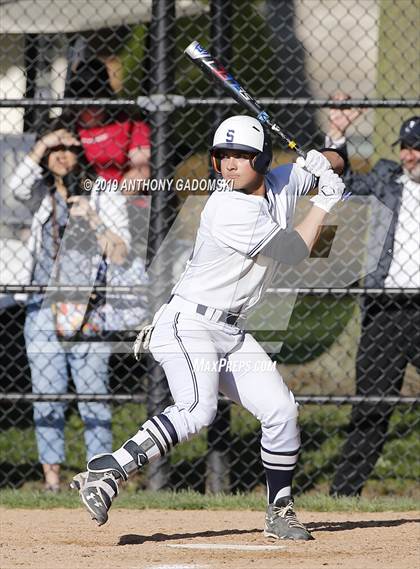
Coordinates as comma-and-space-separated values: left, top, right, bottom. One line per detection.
70, 470, 121, 526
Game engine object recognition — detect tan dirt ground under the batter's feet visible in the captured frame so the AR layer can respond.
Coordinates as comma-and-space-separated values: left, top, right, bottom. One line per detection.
0, 508, 420, 569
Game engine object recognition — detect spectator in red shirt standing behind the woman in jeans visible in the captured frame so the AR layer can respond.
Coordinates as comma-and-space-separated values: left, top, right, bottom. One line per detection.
65, 54, 150, 330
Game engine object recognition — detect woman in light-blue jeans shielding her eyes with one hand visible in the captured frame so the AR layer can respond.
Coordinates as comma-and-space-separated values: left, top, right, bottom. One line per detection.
10, 124, 130, 491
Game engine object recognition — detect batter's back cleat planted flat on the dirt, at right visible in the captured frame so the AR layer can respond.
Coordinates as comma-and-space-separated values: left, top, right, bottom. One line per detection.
264, 496, 314, 541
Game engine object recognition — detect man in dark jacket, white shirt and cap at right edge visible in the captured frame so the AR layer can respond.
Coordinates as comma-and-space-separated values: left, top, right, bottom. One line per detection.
327, 100, 420, 496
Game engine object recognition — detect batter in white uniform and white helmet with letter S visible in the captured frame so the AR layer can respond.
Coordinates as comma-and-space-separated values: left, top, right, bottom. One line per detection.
72, 115, 344, 540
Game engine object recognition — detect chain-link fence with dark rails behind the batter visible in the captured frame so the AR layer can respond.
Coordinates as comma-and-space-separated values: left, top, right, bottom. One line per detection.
0, 0, 420, 494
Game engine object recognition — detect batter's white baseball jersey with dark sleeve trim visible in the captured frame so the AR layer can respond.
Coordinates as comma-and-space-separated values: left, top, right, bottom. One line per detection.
172, 164, 316, 314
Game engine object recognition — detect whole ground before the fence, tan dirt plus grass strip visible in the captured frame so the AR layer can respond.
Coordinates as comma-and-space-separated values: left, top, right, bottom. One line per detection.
0, 491, 420, 569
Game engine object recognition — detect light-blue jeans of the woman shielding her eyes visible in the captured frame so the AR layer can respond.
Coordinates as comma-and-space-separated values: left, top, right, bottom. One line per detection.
24, 307, 112, 464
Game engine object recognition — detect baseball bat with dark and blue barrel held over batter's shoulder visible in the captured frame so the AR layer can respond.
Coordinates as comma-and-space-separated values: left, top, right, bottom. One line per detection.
184, 41, 305, 158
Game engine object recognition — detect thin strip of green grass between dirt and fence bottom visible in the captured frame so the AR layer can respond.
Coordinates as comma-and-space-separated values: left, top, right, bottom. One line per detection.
0, 488, 420, 512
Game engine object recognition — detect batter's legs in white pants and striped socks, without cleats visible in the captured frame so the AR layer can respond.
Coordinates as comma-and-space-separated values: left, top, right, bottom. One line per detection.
113, 296, 300, 503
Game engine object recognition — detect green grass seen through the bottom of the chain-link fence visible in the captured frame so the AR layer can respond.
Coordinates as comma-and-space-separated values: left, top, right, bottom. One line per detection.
0, 404, 420, 496
